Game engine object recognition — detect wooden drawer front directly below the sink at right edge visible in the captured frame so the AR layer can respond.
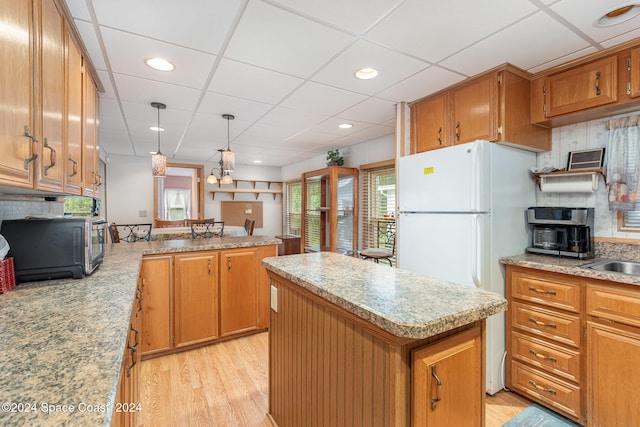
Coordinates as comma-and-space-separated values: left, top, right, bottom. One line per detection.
586, 285, 640, 327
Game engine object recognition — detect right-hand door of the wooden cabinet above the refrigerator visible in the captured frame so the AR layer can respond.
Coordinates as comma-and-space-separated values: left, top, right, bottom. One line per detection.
451, 73, 498, 144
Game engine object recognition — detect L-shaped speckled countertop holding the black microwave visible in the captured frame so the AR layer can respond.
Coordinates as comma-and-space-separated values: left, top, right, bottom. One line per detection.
0, 236, 280, 427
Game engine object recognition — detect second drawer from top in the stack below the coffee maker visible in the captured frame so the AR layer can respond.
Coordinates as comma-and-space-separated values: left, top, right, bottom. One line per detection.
510, 301, 580, 347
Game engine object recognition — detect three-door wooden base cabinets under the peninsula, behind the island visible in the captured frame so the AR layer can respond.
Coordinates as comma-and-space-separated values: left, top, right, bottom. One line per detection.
140, 245, 277, 358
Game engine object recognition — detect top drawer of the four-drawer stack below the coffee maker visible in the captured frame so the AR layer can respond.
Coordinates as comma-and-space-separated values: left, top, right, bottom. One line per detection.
511, 271, 580, 313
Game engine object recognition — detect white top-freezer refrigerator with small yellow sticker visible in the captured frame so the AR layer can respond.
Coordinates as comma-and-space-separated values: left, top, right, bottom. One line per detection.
397, 141, 536, 394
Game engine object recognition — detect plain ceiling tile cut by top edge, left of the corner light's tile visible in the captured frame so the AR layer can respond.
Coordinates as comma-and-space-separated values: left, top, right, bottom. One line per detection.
365, 0, 537, 63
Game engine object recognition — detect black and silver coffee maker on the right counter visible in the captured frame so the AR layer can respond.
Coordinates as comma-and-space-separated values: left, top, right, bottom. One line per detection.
527, 207, 595, 259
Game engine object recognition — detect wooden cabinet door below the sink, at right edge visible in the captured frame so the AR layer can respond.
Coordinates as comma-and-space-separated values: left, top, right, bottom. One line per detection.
587, 321, 640, 426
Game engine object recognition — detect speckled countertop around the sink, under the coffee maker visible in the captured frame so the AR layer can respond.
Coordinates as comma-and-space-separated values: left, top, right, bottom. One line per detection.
500, 249, 640, 285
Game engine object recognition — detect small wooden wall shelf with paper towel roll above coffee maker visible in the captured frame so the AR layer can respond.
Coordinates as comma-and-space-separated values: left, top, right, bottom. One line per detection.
532, 168, 607, 193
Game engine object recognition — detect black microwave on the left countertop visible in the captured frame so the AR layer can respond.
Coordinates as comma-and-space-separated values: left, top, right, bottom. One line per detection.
0, 217, 107, 283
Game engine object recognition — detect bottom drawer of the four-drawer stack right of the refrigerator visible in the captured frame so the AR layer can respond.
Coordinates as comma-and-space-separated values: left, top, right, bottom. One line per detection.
512, 362, 582, 420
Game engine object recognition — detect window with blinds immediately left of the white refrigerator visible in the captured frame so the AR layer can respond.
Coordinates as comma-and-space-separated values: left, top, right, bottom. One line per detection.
361, 162, 396, 265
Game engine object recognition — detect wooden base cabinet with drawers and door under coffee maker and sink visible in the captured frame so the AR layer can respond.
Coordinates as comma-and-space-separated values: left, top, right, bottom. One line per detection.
507, 265, 640, 427
